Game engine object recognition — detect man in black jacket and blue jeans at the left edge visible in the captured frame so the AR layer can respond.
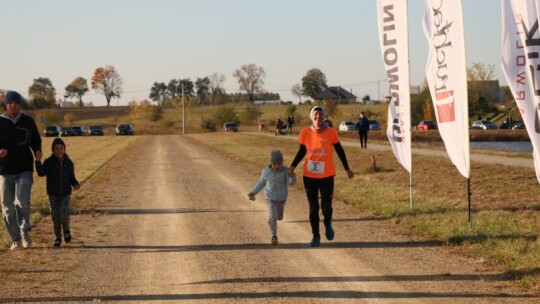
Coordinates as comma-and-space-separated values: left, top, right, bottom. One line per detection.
0, 91, 42, 250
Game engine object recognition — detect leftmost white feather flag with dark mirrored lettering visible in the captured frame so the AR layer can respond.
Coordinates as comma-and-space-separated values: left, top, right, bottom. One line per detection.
377, 0, 412, 173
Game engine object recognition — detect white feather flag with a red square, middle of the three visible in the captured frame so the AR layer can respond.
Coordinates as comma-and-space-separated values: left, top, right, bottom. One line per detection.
423, 0, 470, 178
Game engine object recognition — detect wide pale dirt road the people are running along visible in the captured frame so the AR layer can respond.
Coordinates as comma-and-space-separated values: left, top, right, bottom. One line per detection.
0, 136, 540, 303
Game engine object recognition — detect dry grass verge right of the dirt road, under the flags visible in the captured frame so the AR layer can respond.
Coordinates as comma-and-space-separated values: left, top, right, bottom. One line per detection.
190, 133, 540, 291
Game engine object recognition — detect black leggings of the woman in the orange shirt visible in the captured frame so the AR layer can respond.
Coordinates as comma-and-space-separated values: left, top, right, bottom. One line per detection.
304, 176, 334, 236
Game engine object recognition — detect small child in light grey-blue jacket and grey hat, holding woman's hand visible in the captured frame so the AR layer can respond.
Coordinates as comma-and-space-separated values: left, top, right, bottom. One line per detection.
248, 150, 296, 245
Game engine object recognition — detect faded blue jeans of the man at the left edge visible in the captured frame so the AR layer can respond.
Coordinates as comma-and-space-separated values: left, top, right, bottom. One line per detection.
0, 171, 34, 241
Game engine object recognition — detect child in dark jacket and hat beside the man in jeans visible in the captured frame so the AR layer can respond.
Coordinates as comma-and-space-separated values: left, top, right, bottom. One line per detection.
36, 138, 81, 247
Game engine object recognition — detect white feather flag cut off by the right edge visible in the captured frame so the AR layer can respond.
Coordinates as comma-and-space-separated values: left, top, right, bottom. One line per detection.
501, 0, 540, 182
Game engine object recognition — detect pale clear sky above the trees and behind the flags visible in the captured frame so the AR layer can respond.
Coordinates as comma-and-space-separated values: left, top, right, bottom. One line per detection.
0, 0, 506, 105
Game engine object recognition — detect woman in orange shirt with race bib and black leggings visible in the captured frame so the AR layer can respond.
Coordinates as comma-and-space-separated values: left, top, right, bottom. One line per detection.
288, 106, 354, 247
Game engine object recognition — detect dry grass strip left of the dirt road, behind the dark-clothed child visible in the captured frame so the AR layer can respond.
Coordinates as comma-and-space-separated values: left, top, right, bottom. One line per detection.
0, 136, 136, 247
